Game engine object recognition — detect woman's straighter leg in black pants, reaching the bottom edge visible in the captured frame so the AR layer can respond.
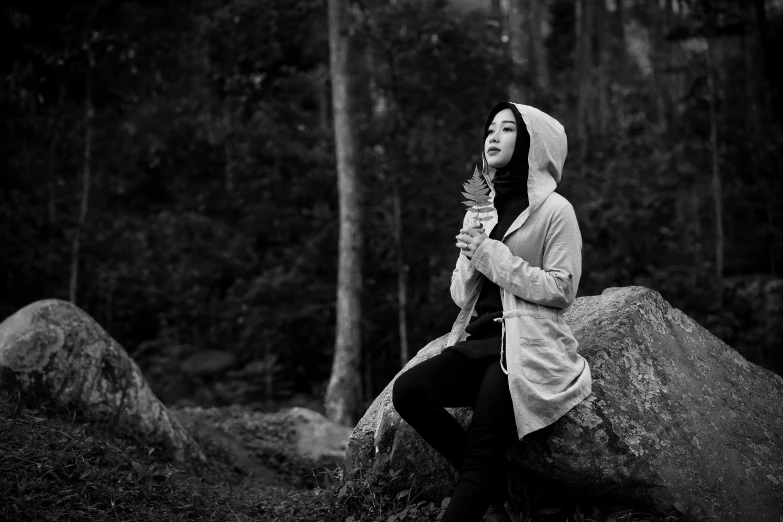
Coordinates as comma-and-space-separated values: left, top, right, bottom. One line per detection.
441, 361, 517, 522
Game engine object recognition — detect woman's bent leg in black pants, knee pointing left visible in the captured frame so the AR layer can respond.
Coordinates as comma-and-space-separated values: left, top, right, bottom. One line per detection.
392, 350, 489, 471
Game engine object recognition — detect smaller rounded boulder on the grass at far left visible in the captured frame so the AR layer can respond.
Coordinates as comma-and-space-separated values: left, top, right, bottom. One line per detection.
0, 299, 205, 461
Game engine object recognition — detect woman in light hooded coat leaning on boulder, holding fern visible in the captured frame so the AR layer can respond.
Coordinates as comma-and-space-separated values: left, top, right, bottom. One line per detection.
392, 102, 592, 522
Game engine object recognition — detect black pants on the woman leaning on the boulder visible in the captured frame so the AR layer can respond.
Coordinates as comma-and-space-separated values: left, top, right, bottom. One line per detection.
392, 350, 517, 522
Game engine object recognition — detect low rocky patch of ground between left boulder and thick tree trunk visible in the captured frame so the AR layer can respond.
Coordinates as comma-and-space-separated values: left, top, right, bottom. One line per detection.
171, 405, 351, 487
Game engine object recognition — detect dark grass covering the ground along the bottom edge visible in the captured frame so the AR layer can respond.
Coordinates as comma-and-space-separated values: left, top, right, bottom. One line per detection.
0, 393, 708, 522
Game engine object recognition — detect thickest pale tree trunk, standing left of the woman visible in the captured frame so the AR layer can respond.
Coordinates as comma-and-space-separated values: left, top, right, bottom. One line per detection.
325, 0, 362, 425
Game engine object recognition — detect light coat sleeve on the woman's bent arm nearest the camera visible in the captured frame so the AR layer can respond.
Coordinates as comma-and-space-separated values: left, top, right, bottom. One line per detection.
470, 199, 582, 308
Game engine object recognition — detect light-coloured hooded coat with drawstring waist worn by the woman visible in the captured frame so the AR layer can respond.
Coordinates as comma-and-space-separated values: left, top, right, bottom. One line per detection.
446, 103, 592, 439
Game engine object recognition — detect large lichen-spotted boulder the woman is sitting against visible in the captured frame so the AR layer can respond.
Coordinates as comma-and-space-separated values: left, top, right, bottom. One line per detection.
346, 287, 783, 522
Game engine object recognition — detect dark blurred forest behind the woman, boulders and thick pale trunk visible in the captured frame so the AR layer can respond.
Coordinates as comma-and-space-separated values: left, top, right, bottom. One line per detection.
0, 0, 783, 422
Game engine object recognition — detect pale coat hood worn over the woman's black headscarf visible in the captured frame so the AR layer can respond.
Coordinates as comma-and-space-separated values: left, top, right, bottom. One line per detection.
481, 103, 568, 213
